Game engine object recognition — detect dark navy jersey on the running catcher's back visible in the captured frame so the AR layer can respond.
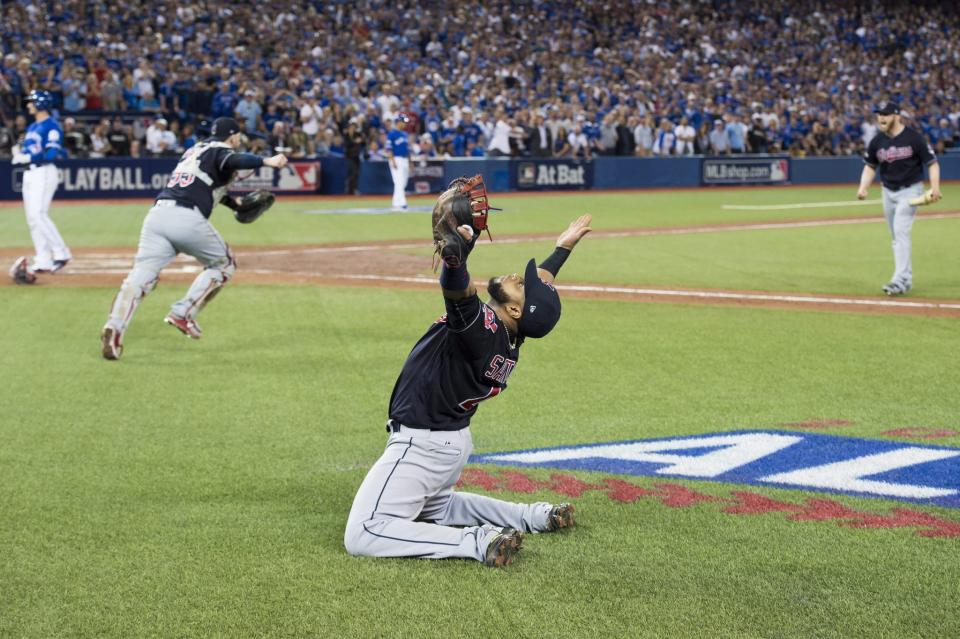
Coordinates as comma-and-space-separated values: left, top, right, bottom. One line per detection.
157, 141, 235, 218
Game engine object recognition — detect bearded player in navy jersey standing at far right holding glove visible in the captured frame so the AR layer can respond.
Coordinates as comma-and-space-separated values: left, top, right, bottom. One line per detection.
857, 102, 942, 295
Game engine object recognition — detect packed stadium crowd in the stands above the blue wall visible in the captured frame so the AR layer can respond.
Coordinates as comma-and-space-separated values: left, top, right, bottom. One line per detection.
0, 0, 960, 170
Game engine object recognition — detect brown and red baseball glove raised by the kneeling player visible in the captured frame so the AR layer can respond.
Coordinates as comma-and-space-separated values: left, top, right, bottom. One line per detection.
431, 175, 499, 270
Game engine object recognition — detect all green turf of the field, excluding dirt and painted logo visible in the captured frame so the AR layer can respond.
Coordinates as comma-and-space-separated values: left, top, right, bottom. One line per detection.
0, 186, 960, 639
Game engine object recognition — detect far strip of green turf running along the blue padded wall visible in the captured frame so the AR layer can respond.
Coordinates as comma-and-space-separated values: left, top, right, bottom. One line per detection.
0, 184, 960, 247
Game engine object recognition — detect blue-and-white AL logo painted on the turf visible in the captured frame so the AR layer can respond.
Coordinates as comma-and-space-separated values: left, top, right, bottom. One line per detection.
471, 431, 960, 508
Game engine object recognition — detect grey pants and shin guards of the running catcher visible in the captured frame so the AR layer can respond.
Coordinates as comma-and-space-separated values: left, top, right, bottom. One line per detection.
106, 202, 236, 334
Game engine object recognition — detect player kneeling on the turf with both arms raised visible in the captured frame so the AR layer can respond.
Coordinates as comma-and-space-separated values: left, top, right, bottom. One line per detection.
344, 176, 591, 567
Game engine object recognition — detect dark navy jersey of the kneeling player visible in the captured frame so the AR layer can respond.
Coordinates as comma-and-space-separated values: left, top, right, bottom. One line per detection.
390, 295, 520, 430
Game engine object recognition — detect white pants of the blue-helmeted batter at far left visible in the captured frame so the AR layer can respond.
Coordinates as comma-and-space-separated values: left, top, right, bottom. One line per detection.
23, 164, 71, 271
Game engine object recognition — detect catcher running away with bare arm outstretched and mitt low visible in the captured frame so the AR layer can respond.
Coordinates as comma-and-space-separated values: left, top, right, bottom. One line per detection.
101, 118, 287, 359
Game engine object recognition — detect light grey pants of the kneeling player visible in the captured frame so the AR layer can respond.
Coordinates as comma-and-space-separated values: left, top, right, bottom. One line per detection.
343, 426, 552, 561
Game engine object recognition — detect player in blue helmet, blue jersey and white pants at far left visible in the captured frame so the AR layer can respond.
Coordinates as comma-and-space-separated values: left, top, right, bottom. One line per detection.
10, 91, 71, 284
